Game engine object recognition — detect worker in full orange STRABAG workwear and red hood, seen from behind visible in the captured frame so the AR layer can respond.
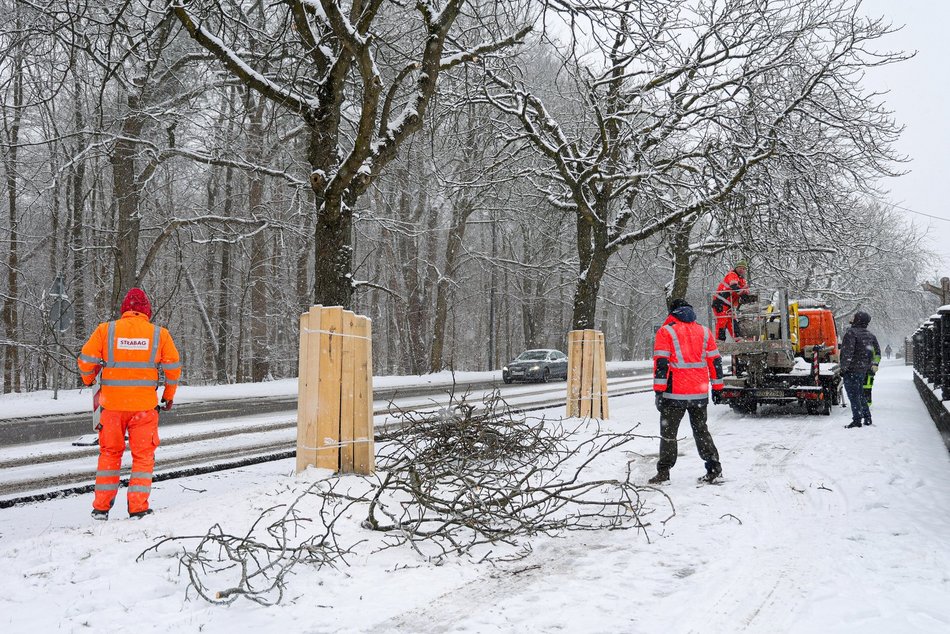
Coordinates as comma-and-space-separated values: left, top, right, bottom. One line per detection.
78, 288, 181, 520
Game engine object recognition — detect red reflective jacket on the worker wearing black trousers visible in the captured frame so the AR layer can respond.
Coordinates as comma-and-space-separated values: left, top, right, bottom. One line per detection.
653, 317, 722, 401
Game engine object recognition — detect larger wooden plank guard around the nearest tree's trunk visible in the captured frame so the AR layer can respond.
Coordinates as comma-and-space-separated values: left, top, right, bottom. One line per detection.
297, 306, 376, 474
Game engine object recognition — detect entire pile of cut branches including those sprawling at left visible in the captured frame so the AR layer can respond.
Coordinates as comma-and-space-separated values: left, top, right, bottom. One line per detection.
139, 392, 668, 605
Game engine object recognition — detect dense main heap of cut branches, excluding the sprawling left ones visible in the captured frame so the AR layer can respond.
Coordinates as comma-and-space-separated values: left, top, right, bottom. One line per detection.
356, 392, 660, 559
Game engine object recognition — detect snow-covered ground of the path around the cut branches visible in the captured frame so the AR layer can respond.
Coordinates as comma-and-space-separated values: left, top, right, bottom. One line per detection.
0, 364, 950, 634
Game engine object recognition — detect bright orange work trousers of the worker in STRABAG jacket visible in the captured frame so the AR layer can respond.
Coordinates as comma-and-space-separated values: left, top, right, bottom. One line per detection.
92, 409, 159, 513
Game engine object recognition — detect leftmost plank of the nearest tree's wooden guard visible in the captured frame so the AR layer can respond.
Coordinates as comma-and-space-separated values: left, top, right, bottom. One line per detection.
297, 306, 321, 473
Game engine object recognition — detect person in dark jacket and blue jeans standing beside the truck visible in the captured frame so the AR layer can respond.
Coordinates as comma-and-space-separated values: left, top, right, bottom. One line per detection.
838, 310, 881, 429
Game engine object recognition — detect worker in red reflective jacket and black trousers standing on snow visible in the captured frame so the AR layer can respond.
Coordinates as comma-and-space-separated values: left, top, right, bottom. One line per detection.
650, 299, 722, 484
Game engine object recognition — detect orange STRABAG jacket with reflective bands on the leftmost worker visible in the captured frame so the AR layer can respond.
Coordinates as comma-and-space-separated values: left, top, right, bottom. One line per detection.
77, 310, 181, 412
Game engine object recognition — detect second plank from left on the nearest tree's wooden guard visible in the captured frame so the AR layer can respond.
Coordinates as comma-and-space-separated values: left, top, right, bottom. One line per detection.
316, 306, 344, 471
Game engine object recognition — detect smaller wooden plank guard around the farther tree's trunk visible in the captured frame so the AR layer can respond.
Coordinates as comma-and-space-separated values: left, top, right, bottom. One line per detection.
567, 330, 610, 419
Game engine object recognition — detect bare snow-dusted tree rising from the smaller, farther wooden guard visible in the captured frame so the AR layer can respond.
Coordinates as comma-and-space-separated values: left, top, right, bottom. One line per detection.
486, 0, 904, 328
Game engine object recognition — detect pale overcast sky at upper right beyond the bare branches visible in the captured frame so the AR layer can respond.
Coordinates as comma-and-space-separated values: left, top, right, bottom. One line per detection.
863, 0, 950, 277
